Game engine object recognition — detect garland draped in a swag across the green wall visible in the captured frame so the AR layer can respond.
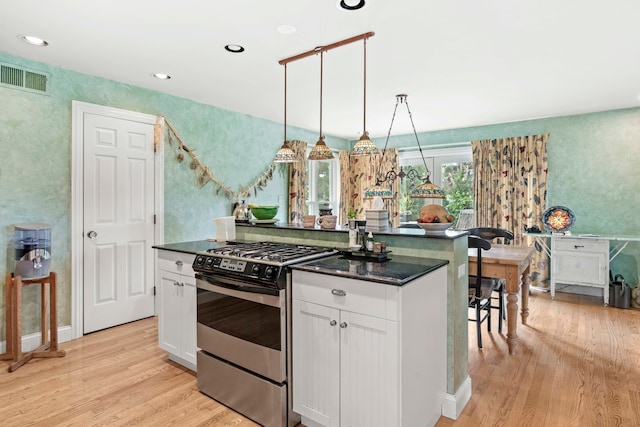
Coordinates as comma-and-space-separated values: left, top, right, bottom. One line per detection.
154, 116, 276, 201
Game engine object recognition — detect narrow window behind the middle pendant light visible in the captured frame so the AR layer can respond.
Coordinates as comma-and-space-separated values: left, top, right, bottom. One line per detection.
306, 157, 340, 215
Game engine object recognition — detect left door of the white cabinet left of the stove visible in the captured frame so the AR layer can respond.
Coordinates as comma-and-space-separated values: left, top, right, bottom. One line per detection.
158, 270, 182, 354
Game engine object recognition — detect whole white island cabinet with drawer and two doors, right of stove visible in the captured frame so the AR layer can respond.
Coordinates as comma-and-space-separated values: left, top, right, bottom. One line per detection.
292, 267, 447, 427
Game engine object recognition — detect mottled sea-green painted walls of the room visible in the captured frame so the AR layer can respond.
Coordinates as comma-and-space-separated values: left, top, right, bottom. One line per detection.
0, 53, 640, 333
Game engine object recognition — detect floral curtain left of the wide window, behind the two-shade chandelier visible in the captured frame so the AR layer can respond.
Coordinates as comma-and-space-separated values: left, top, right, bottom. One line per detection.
338, 148, 400, 227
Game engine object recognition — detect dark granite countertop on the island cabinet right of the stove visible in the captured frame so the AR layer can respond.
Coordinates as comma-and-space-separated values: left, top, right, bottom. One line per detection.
291, 254, 449, 286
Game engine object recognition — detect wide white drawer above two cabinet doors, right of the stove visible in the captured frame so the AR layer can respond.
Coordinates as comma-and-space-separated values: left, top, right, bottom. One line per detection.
293, 270, 399, 320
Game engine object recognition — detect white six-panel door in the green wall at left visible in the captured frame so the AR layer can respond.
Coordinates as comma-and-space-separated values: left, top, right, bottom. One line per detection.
83, 113, 154, 334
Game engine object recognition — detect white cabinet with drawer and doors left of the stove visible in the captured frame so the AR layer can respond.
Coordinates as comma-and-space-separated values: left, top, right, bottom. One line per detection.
156, 250, 197, 371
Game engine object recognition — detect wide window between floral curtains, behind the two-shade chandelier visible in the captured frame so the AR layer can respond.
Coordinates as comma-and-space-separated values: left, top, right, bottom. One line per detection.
398, 146, 473, 223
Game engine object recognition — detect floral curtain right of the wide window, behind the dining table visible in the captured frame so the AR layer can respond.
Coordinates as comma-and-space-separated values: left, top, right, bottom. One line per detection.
471, 134, 549, 288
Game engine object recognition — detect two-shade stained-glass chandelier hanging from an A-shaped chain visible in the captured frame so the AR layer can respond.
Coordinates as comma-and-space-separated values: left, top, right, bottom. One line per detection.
363, 94, 445, 199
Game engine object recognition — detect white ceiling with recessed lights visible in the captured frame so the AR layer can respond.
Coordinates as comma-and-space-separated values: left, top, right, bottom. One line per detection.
0, 0, 640, 139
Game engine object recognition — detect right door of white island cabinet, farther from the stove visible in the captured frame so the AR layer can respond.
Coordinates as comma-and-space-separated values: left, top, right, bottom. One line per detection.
339, 311, 400, 427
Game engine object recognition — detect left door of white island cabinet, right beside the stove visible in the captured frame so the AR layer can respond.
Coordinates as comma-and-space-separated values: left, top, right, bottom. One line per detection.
292, 300, 340, 426
